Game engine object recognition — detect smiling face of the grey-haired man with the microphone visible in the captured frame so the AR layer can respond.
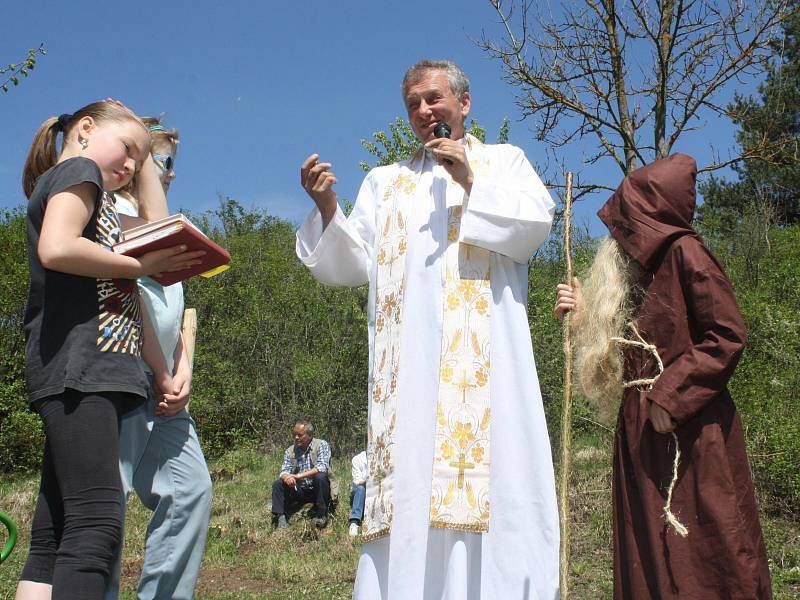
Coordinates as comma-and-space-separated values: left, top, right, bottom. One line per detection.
405, 69, 470, 144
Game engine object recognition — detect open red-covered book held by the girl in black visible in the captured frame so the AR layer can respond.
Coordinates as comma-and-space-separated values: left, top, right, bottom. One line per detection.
113, 213, 231, 285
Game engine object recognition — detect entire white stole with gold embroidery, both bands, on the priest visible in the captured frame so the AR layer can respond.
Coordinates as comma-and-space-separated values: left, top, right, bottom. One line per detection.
363, 136, 491, 541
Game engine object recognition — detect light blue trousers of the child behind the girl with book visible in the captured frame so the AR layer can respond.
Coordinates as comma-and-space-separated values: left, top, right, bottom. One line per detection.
106, 390, 211, 600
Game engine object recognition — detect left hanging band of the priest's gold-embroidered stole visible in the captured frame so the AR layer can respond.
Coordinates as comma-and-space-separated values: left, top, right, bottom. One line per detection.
362, 152, 422, 541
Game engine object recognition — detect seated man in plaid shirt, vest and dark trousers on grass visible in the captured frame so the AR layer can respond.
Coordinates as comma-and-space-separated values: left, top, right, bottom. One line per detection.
272, 421, 331, 529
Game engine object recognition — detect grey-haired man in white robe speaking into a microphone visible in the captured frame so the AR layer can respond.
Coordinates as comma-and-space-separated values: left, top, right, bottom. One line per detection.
297, 61, 559, 600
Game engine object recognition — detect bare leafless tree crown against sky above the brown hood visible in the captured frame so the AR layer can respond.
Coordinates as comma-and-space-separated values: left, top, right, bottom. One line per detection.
477, 0, 789, 193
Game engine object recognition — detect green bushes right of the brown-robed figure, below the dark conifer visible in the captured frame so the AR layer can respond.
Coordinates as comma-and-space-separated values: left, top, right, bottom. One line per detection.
721, 225, 800, 513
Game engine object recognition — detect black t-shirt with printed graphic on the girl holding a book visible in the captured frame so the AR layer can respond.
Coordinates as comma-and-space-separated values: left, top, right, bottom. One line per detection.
25, 157, 147, 402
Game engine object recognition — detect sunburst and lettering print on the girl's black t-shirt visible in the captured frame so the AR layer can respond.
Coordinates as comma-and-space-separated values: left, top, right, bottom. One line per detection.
97, 192, 142, 356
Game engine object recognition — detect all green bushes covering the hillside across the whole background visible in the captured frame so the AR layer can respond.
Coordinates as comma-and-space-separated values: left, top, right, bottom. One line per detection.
0, 199, 800, 512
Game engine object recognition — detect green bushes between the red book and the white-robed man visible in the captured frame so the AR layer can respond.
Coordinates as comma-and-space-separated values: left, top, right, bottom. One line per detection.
184, 198, 367, 455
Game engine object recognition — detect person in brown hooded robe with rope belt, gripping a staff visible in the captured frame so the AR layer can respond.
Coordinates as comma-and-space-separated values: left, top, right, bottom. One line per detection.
556, 154, 772, 600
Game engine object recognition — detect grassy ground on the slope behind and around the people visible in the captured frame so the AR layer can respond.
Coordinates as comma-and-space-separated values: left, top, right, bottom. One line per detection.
0, 437, 800, 600
